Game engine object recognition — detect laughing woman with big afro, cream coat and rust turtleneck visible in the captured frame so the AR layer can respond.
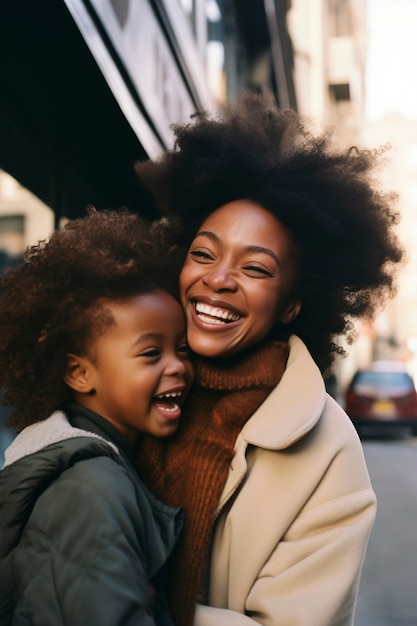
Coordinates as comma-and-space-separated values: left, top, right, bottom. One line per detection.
136, 94, 403, 626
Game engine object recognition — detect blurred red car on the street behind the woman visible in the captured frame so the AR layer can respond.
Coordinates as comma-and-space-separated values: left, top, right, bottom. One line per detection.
345, 361, 417, 435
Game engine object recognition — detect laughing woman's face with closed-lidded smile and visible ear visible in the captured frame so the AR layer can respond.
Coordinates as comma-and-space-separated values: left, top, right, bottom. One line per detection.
180, 200, 300, 357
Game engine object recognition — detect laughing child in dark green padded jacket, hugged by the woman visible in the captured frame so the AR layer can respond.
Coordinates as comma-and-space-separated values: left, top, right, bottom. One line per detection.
0, 210, 193, 626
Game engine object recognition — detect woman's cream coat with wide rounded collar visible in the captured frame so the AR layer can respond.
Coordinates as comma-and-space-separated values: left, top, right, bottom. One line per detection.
195, 336, 376, 626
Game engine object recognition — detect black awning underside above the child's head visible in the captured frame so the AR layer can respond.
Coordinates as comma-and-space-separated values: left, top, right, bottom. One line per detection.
0, 0, 158, 219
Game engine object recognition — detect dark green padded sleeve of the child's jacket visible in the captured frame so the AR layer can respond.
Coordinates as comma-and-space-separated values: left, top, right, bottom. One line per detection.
15, 457, 169, 626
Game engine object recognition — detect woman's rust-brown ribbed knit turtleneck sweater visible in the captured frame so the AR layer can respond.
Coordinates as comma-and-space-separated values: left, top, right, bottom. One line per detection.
138, 341, 289, 626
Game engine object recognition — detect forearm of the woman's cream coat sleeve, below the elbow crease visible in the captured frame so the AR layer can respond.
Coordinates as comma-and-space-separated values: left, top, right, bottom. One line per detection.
247, 489, 375, 626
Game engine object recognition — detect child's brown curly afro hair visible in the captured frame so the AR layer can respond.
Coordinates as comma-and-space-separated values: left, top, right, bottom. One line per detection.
0, 208, 184, 430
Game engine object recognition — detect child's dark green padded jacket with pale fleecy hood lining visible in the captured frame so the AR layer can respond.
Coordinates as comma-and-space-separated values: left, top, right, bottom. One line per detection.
0, 412, 182, 626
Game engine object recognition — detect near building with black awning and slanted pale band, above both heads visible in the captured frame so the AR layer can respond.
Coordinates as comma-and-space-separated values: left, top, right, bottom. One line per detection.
0, 0, 297, 243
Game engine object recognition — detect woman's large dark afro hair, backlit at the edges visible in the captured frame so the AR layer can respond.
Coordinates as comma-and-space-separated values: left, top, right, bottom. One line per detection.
135, 92, 404, 372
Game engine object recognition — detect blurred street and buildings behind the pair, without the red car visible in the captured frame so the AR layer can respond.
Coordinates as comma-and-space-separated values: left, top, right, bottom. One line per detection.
0, 0, 417, 626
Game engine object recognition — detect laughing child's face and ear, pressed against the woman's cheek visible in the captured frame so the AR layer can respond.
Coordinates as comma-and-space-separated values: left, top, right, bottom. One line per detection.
65, 291, 193, 445
